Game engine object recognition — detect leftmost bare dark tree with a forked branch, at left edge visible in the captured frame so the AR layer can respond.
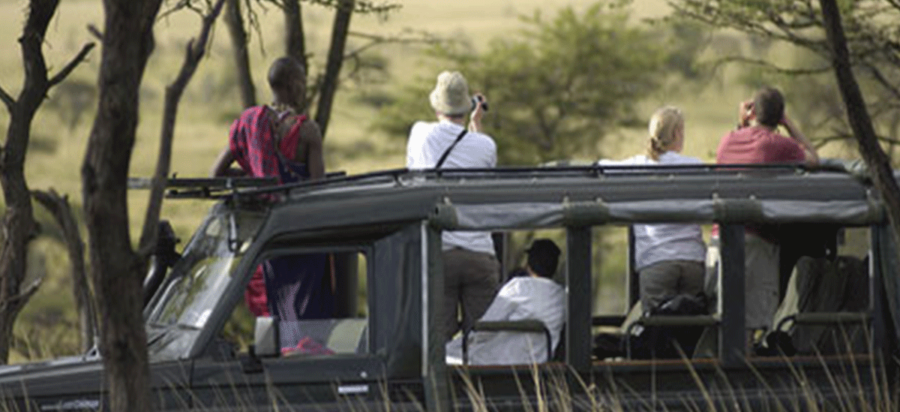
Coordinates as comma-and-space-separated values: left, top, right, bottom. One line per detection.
0, 0, 93, 363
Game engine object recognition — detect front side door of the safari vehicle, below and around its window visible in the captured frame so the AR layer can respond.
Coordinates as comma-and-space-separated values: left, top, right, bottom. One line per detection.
192, 240, 394, 410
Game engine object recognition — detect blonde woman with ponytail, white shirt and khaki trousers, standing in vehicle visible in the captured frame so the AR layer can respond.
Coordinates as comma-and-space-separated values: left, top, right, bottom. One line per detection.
599, 106, 706, 312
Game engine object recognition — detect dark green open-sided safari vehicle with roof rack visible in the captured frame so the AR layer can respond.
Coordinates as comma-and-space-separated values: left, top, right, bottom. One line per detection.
0, 165, 900, 411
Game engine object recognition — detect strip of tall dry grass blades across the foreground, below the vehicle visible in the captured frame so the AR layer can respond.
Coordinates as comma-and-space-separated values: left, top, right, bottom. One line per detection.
0, 327, 900, 412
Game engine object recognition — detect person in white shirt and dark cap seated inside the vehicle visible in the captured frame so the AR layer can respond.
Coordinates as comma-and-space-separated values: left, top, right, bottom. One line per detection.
446, 239, 566, 365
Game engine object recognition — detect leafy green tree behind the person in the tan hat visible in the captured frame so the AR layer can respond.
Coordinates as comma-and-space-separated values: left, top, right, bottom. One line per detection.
375, 1, 669, 165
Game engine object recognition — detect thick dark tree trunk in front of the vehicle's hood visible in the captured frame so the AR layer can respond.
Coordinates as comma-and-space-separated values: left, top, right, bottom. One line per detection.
81, 0, 162, 412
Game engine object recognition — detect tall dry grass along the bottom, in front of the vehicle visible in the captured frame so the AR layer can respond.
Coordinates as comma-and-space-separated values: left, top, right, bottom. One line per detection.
0, 355, 898, 412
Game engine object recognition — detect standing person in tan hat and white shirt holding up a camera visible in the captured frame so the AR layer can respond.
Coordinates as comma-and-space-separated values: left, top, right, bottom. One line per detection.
406, 72, 500, 341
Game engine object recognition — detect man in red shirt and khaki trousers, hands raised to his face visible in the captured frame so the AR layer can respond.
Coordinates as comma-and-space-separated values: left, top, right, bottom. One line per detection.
716, 87, 819, 338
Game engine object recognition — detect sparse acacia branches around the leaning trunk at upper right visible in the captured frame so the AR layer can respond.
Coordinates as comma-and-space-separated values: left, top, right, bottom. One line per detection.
669, 0, 900, 151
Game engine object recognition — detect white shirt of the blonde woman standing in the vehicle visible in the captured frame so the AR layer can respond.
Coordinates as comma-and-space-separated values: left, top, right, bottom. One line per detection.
597, 152, 706, 270
